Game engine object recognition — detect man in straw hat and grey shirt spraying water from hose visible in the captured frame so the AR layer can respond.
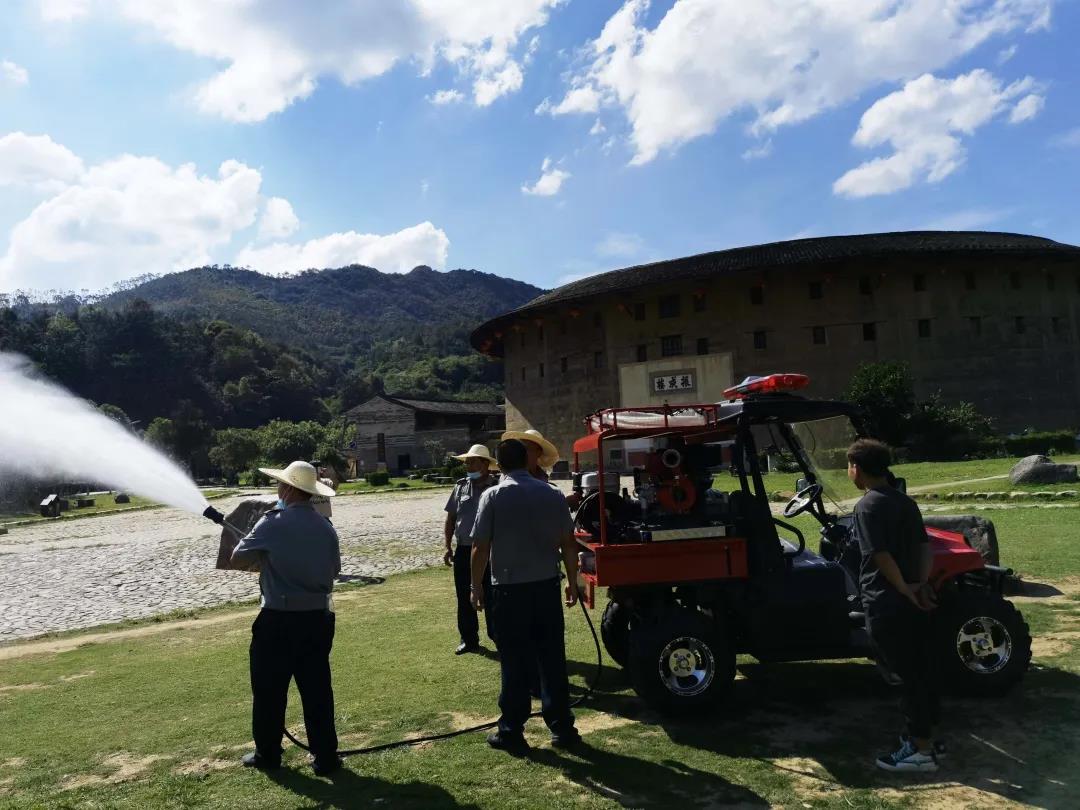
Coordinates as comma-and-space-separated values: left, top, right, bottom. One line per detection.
232, 461, 341, 775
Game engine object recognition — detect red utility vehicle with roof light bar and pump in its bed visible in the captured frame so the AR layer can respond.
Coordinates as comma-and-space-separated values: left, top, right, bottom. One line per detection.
573, 375, 1031, 711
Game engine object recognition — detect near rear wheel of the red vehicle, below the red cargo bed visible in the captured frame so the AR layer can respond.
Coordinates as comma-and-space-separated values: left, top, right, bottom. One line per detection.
627, 609, 735, 714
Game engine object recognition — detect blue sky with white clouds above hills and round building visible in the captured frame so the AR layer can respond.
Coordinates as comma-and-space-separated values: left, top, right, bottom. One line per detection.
0, 0, 1080, 292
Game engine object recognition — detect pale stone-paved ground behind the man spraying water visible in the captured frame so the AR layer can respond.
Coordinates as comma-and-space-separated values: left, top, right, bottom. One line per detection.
0, 489, 449, 643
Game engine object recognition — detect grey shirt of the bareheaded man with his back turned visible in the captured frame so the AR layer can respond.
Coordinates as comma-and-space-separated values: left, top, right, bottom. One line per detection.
472, 470, 573, 585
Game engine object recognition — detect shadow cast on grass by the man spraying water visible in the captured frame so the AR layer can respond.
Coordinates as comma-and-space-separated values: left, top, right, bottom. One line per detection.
266, 766, 476, 810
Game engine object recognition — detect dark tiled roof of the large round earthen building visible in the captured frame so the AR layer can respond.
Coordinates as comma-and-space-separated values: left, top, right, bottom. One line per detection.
471, 231, 1080, 354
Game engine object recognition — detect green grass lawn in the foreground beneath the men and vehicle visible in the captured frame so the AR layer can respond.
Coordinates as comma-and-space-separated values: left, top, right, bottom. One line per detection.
0, 568, 1080, 809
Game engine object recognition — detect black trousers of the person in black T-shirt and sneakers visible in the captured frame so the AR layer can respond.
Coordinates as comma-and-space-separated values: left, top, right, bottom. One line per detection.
866, 606, 941, 739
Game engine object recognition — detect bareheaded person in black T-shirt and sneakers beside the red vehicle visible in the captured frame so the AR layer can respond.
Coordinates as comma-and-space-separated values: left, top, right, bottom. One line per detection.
848, 438, 944, 771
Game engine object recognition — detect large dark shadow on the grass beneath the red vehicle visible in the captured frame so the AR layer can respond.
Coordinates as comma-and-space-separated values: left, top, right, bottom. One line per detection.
570, 661, 1080, 808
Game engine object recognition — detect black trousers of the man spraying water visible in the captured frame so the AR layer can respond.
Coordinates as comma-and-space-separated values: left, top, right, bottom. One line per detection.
251, 608, 338, 762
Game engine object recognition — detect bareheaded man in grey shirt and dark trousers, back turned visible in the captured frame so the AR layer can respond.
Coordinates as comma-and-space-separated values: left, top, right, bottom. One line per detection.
472, 440, 581, 753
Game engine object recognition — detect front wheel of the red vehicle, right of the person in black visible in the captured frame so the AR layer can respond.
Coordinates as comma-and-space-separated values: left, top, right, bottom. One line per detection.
935, 593, 1031, 697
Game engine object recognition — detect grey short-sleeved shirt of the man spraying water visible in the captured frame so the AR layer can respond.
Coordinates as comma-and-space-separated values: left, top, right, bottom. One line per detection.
232, 503, 341, 610
